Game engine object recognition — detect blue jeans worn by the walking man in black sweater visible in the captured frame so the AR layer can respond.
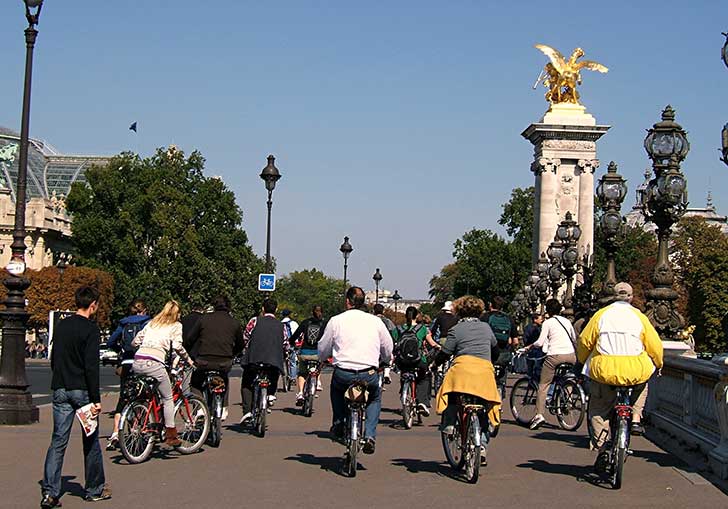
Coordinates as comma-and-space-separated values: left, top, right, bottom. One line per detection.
41, 389, 106, 497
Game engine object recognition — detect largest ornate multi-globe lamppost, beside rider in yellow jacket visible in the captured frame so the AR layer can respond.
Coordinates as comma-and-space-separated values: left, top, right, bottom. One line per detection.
645, 105, 690, 340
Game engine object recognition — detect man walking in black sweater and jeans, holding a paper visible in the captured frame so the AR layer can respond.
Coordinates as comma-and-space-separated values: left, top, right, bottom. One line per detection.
40, 286, 111, 508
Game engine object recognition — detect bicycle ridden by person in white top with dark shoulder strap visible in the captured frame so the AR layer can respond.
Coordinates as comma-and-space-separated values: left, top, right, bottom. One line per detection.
510, 356, 586, 431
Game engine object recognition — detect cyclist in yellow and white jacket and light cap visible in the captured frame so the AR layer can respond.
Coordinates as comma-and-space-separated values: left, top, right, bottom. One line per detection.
577, 283, 663, 471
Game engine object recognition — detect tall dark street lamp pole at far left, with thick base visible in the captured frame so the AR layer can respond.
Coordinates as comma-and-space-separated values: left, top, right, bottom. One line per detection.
0, 0, 43, 424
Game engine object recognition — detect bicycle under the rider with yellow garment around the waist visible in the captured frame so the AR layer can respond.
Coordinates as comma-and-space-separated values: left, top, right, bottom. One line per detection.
440, 393, 490, 484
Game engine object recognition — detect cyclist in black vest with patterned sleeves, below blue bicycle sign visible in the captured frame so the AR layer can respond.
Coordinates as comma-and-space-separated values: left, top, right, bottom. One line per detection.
240, 298, 284, 424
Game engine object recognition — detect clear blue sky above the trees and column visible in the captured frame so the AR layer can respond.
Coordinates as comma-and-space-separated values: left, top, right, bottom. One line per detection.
0, 0, 728, 298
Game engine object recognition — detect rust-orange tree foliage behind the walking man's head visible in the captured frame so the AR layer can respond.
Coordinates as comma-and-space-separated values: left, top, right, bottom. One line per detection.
0, 266, 114, 328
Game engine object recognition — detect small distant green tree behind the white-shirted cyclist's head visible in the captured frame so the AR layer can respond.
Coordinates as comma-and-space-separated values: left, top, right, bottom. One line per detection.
275, 269, 344, 322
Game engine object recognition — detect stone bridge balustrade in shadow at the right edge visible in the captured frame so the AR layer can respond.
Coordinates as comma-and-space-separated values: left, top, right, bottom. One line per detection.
647, 352, 728, 479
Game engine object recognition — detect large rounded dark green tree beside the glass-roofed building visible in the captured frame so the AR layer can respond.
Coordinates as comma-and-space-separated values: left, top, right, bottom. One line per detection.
67, 148, 263, 318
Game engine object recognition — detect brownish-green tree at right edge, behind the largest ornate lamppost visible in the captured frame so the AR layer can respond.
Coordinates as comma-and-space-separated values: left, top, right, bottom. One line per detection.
671, 217, 728, 352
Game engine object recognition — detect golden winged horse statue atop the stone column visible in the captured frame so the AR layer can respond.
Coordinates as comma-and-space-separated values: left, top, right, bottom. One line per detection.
533, 44, 609, 104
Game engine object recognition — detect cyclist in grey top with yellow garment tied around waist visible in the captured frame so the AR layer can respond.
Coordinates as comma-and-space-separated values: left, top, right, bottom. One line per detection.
434, 295, 501, 462
